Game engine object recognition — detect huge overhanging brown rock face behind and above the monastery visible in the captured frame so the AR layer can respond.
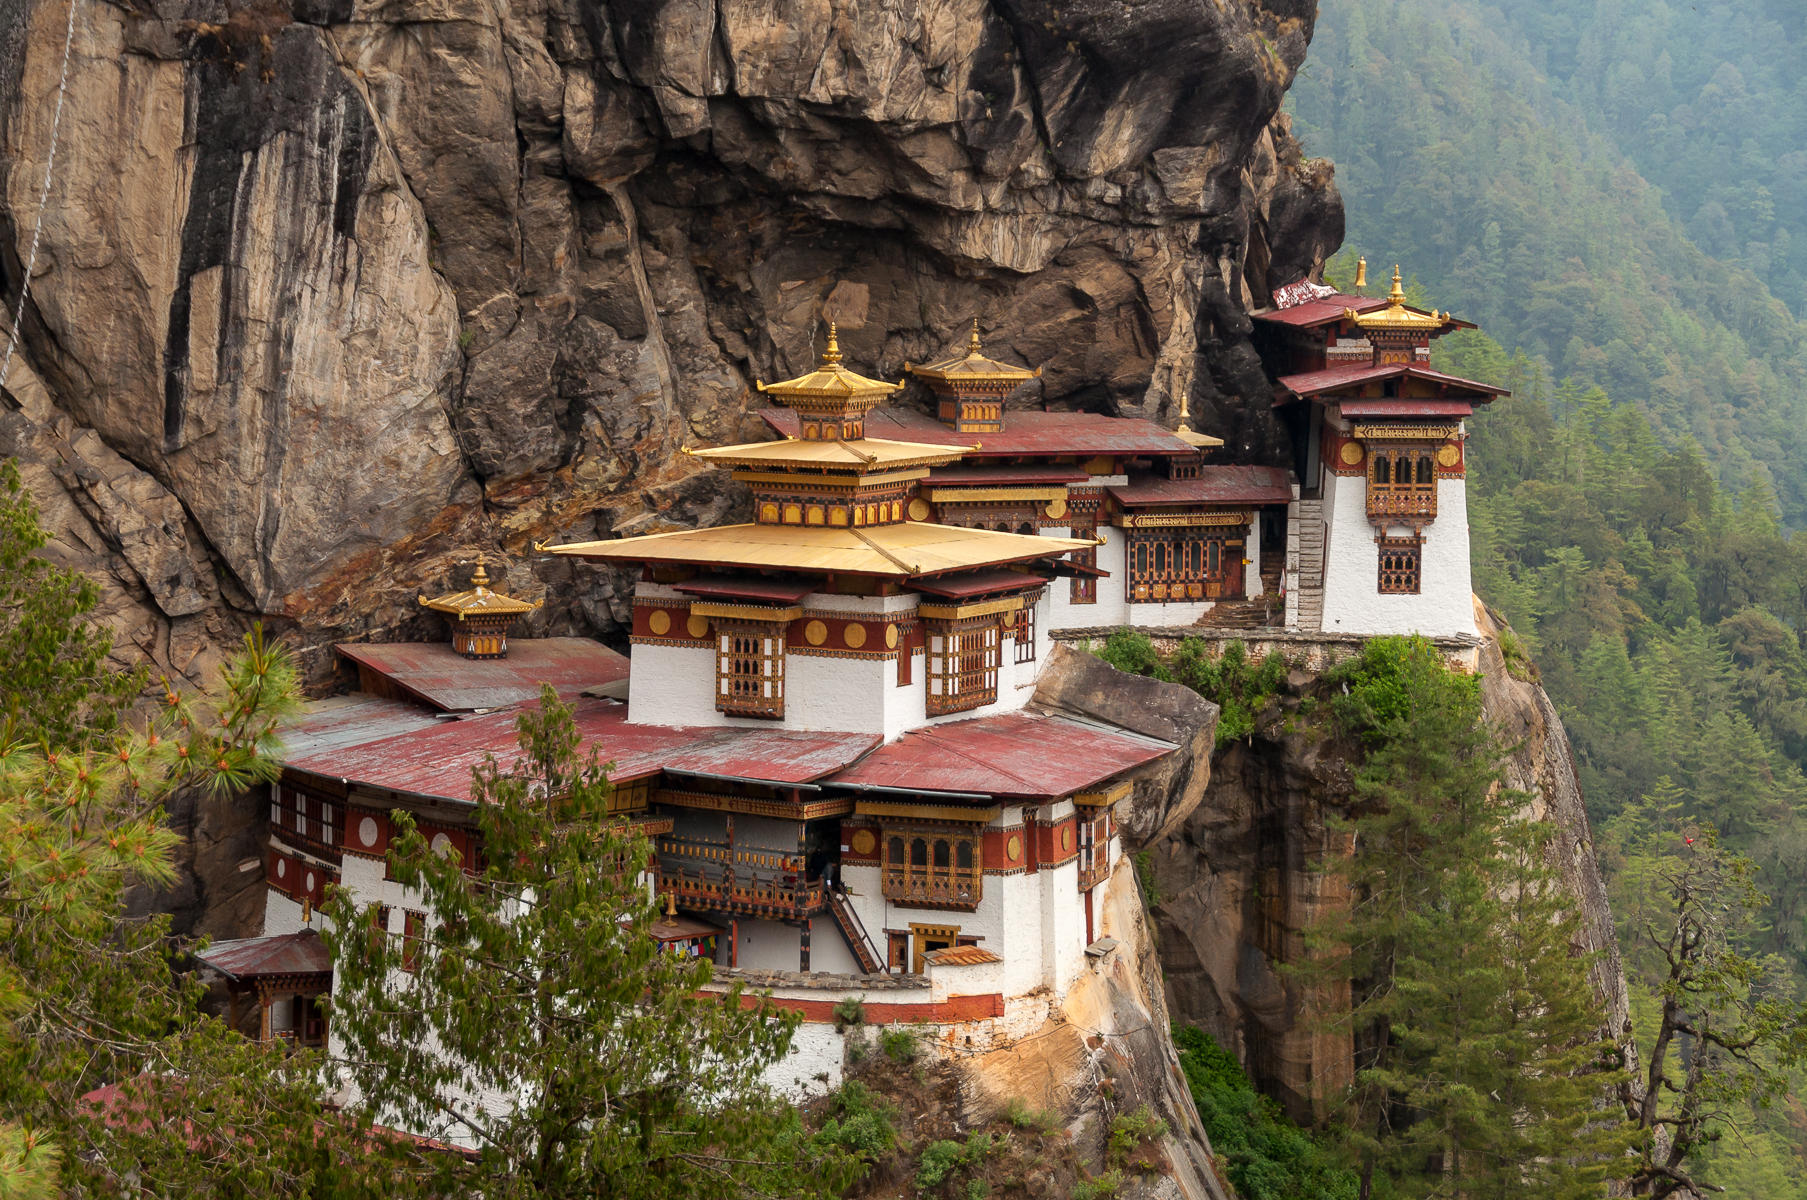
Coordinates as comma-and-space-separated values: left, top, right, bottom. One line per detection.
0, 0, 1343, 678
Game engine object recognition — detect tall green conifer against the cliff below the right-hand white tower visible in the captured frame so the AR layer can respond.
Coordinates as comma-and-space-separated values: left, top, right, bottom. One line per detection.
1308, 638, 1634, 1200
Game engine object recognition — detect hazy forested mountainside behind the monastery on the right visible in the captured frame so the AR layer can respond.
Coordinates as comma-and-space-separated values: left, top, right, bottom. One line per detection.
1294, 0, 1807, 1200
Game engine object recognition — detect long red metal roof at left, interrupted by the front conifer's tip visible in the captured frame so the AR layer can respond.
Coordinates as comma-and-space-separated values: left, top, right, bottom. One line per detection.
286, 698, 880, 802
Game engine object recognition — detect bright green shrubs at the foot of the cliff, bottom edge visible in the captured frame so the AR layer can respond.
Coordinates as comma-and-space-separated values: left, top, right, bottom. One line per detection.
1173, 1027, 1361, 1200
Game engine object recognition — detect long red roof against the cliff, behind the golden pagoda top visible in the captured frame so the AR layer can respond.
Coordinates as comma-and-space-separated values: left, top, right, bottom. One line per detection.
759, 408, 1198, 461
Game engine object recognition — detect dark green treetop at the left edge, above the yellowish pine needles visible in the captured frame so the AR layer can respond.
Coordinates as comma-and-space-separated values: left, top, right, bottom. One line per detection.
0, 461, 145, 750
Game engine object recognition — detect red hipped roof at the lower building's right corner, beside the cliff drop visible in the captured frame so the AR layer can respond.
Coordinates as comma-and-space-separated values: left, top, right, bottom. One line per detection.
829, 712, 1175, 799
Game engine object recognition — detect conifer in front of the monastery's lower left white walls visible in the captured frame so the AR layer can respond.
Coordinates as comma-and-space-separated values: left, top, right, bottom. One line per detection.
327, 689, 838, 1198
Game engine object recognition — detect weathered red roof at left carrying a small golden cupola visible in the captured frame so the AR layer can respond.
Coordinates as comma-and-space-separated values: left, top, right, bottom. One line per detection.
338, 638, 627, 712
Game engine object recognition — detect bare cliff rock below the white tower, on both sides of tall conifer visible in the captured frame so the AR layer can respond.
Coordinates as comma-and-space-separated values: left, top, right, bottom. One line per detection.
1149, 618, 1635, 1120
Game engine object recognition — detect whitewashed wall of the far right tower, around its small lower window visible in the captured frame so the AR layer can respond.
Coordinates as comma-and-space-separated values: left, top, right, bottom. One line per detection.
1325, 473, 1475, 638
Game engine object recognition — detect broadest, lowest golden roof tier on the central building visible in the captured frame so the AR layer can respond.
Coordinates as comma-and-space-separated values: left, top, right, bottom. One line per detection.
538, 522, 1097, 578
